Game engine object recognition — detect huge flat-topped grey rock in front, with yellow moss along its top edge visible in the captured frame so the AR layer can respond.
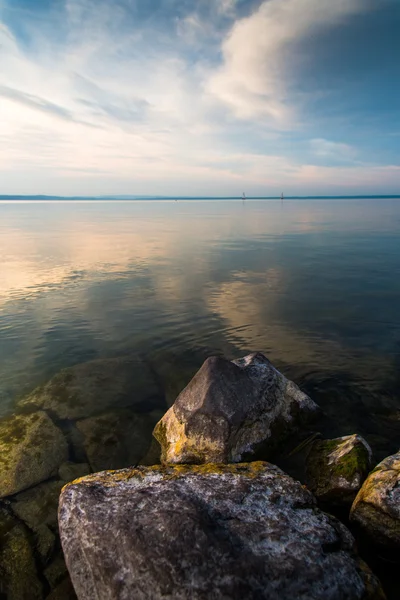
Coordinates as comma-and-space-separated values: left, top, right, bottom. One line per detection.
59, 462, 384, 600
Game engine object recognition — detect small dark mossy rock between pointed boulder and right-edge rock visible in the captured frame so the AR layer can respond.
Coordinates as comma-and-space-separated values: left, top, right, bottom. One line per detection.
306, 435, 372, 507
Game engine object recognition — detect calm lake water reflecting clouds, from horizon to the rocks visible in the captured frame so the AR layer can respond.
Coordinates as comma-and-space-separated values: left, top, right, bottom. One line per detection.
0, 200, 400, 457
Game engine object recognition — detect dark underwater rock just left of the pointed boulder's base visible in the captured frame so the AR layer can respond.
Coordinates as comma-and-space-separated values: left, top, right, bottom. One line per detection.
76, 410, 162, 471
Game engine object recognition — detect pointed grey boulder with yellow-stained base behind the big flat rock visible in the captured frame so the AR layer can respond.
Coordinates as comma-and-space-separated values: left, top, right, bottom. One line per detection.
153, 353, 318, 464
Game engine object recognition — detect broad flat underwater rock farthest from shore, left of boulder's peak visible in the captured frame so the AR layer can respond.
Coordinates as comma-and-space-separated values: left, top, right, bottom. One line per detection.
18, 356, 163, 420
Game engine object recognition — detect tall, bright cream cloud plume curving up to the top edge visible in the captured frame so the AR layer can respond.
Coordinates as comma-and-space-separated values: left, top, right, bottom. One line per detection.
207, 0, 366, 127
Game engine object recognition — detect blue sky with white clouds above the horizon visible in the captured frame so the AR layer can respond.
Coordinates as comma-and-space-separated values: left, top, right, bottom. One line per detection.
0, 0, 400, 196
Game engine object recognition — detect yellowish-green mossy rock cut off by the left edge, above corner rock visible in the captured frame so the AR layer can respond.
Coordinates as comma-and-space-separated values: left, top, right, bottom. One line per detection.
0, 412, 68, 498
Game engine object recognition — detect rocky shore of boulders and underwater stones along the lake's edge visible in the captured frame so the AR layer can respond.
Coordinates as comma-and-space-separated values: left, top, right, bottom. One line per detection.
0, 353, 400, 600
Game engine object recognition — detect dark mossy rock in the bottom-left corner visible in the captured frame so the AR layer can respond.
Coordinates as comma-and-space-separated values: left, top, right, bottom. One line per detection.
0, 508, 43, 600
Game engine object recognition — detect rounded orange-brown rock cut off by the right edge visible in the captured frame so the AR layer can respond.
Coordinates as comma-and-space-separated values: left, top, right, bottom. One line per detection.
350, 451, 400, 557
